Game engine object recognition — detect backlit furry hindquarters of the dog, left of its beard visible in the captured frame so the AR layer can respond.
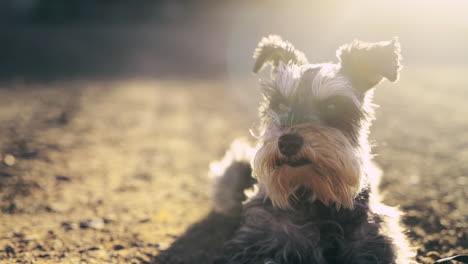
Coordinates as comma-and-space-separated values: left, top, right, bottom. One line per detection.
210, 140, 256, 215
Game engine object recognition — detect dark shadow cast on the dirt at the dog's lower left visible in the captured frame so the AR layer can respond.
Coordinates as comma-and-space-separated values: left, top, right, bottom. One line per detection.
152, 211, 240, 264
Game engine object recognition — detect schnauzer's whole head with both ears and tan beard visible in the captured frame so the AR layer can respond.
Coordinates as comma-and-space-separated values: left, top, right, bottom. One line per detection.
253, 36, 401, 208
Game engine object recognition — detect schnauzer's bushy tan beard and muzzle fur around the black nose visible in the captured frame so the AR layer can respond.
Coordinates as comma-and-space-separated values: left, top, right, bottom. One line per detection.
254, 125, 362, 209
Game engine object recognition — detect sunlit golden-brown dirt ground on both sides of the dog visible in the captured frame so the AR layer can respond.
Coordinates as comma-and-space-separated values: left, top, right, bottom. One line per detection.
0, 66, 468, 264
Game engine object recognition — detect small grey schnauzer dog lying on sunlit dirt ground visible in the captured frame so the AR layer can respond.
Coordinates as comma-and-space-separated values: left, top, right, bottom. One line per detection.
212, 36, 414, 264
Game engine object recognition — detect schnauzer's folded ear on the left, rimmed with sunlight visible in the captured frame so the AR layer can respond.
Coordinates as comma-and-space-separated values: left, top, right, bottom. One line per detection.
253, 35, 308, 73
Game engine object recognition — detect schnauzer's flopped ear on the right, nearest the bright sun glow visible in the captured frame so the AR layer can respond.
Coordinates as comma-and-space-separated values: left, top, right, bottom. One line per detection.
336, 38, 401, 92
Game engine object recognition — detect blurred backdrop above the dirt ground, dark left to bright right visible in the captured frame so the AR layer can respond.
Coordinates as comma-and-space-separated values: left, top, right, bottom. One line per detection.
0, 0, 468, 79
